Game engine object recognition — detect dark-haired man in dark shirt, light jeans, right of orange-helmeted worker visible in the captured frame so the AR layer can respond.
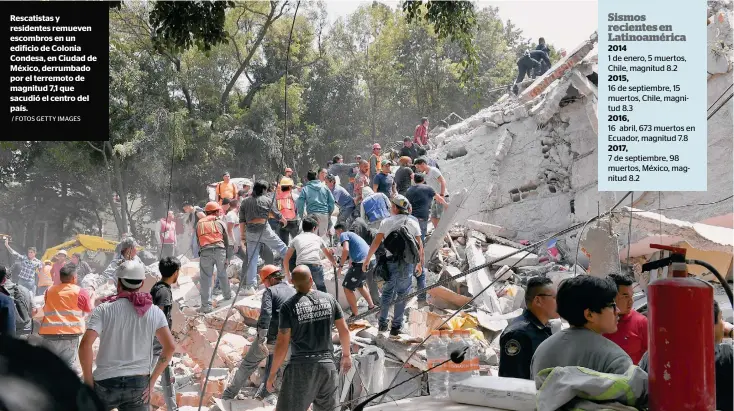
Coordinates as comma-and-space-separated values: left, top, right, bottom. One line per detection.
240, 180, 288, 295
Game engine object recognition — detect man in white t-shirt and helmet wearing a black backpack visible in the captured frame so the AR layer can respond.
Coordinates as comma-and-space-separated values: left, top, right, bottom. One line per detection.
362, 194, 424, 337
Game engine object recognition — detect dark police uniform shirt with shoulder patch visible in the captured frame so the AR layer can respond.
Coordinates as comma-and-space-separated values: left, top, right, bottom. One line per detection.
499, 309, 551, 380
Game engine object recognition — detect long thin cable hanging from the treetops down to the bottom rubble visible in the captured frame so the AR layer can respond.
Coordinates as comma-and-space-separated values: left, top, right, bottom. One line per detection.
197, 0, 301, 411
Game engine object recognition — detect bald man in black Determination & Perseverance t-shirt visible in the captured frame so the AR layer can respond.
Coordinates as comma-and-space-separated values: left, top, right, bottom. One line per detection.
267, 265, 352, 411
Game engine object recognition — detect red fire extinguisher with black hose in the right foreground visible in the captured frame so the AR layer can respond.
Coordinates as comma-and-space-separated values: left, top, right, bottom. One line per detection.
643, 244, 716, 411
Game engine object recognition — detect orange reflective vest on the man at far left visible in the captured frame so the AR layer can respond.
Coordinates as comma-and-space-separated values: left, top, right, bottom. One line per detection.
38, 283, 84, 335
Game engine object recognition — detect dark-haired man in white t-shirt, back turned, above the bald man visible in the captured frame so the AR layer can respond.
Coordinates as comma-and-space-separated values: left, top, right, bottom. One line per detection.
284, 216, 336, 293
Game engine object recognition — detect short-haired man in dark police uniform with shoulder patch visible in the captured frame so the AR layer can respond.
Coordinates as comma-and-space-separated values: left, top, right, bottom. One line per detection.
499, 277, 558, 380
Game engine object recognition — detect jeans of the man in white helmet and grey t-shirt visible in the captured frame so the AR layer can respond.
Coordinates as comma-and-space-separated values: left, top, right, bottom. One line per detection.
94, 375, 150, 411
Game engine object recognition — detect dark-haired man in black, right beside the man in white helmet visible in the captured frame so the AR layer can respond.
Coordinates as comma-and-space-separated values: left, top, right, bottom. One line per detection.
150, 257, 181, 411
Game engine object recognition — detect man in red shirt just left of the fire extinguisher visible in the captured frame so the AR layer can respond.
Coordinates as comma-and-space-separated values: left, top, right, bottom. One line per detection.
604, 274, 648, 364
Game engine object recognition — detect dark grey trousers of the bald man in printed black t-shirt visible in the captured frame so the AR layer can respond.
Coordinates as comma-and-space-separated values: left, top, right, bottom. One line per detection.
275, 362, 339, 411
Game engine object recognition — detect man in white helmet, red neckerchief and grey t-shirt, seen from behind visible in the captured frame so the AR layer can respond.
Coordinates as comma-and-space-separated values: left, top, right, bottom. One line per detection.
79, 261, 176, 411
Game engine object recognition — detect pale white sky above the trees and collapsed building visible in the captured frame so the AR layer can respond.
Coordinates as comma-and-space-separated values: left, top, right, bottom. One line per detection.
325, 0, 598, 51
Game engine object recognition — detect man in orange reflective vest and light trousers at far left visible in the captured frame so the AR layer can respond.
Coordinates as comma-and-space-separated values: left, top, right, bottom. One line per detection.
38, 263, 94, 376
